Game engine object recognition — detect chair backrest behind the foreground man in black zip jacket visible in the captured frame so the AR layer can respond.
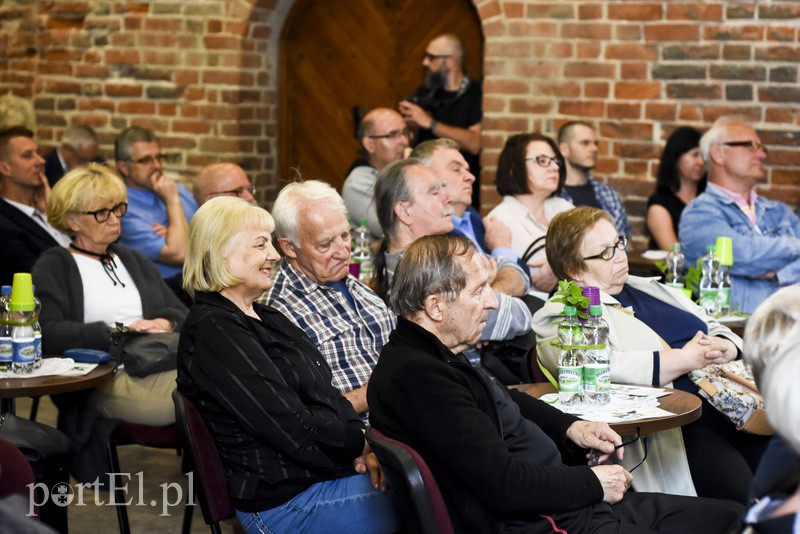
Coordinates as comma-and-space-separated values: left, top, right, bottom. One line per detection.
367, 427, 453, 534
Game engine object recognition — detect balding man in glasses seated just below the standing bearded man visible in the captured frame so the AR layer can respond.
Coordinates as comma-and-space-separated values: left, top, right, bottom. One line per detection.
342, 108, 408, 241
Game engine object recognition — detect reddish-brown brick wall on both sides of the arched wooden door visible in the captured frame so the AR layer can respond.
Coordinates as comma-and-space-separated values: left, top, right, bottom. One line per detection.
0, 0, 800, 245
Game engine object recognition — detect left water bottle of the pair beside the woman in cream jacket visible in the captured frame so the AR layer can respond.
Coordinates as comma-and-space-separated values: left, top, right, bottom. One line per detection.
558, 306, 583, 405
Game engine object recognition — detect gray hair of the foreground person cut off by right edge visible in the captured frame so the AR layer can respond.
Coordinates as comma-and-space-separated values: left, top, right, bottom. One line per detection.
744, 286, 800, 453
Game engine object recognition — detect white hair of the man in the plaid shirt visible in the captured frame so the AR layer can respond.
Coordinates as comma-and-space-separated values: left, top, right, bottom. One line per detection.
272, 180, 347, 245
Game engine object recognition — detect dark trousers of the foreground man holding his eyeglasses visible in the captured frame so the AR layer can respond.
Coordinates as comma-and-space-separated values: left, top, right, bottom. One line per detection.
503, 492, 744, 534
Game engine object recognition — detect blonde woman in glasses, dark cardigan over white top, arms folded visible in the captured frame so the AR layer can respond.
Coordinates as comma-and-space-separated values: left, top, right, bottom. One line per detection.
33, 163, 188, 482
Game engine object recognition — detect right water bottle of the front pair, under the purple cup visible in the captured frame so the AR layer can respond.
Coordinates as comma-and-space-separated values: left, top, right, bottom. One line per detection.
583, 306, 611, 404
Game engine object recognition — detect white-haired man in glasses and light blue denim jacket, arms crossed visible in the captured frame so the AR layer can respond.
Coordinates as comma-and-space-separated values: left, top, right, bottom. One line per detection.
678, 117, 800, 313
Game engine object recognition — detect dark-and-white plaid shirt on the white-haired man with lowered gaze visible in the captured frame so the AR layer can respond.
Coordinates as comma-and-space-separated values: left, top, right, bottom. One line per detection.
266, 260, 395, 393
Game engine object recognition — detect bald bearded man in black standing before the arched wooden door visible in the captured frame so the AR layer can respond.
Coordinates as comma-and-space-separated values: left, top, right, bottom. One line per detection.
400, 33, 483, 208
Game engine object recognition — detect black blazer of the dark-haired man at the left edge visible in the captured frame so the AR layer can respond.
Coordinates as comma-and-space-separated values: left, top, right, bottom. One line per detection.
0, 198, 58, 285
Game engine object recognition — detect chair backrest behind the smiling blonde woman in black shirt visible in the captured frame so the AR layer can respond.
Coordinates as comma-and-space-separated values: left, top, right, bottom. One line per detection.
172, 389, 236, 526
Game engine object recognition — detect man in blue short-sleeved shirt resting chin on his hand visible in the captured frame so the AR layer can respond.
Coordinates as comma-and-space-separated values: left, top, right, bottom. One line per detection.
114, 126, 197, 282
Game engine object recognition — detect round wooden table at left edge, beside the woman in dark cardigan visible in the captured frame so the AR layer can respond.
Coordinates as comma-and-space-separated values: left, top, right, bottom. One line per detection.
0, 362, 116, 415
